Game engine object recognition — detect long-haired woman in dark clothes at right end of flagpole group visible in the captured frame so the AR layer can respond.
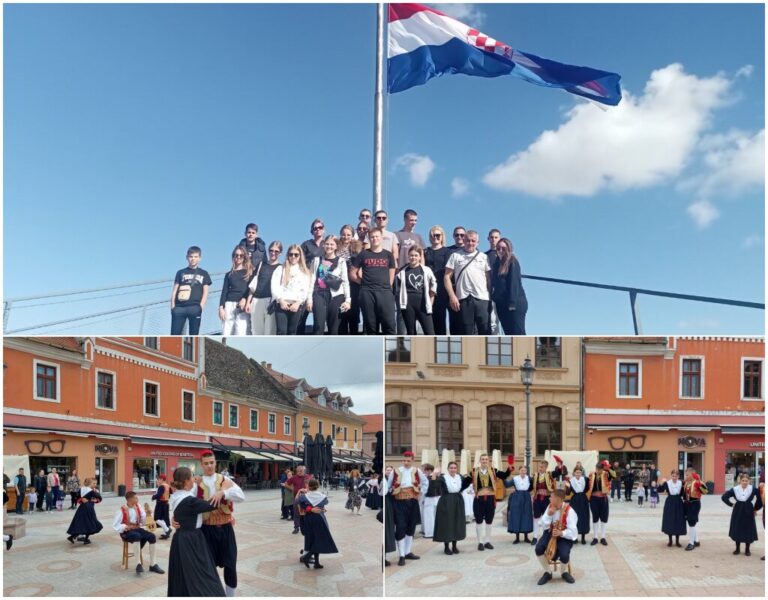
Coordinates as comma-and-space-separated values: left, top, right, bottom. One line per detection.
491, 238, 528, 335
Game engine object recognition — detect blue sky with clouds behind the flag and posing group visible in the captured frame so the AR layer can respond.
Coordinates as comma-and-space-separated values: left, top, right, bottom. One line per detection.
4, 4, 765, 334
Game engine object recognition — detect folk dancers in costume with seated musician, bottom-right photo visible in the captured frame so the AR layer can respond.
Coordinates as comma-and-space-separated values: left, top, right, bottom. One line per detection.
383, 451, 764, 585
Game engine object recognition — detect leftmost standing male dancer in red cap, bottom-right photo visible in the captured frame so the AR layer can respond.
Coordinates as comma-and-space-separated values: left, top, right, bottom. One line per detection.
389, 450, 421, 567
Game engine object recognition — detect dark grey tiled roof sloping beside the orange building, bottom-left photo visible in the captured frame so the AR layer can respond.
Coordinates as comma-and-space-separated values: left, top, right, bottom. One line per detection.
204, 338, 297, 409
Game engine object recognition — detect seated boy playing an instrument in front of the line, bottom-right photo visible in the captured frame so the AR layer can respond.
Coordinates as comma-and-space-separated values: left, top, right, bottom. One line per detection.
535, 490, 579, 585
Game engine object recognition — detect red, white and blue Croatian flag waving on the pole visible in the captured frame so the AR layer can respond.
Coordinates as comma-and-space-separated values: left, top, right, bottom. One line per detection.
387, 4, 621, 106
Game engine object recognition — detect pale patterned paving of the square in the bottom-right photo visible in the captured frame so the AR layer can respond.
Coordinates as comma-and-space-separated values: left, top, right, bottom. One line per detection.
384, 496, 765, 597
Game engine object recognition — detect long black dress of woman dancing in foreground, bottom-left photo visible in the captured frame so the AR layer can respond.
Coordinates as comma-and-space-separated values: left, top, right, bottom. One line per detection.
168, 496, 224, 597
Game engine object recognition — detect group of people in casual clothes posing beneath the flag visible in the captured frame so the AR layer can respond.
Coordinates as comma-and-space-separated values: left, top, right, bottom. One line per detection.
171, 209, 528, 335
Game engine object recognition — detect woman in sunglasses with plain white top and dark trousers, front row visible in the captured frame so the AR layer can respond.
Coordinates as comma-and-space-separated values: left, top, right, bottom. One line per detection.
271, 244, 312, 335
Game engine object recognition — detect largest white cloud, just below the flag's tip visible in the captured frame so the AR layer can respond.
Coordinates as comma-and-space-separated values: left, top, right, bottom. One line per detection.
483, 63, 732, 199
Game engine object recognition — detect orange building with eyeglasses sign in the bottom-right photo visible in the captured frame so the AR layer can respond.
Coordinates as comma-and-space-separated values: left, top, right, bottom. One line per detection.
584, 337, 765, 493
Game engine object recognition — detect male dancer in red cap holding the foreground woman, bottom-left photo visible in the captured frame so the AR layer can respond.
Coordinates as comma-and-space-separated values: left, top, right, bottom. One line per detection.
197, 450, 245, 596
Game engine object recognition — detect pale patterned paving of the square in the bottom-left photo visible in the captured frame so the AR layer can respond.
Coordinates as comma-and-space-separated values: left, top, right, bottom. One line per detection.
3, 490, 383, 597
